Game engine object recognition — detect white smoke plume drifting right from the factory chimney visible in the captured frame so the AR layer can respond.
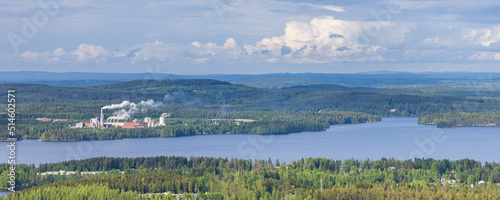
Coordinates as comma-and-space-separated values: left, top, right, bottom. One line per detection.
101, 99, 163, 120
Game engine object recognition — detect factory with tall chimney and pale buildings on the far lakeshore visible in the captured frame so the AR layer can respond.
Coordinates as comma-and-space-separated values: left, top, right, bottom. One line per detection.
74, 109, 170, 128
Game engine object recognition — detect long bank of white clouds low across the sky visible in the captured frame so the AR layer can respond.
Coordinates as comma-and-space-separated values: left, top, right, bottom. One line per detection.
7, 10, 500, 69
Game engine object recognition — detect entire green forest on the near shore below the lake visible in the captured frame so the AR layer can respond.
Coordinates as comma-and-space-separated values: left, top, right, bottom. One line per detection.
0, 156, 500, 199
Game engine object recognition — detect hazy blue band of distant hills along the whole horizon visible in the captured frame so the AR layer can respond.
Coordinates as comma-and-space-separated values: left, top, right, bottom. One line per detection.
0, 71, 500, 88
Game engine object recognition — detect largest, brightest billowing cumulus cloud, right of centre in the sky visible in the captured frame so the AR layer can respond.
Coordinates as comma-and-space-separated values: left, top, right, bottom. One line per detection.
243, 16, 392, 63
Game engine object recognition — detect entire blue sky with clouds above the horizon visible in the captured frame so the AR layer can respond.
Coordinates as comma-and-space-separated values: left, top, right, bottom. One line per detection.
0, 0, 500, 74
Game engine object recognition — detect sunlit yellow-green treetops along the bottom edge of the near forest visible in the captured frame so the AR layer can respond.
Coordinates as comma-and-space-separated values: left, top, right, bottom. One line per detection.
4, 180, 500, 200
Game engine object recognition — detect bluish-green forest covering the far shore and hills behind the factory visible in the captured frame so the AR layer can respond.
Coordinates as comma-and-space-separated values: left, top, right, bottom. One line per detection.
0, 79, 500, 141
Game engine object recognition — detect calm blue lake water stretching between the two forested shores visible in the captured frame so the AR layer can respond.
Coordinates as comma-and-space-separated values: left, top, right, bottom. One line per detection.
0, 118, 500, 166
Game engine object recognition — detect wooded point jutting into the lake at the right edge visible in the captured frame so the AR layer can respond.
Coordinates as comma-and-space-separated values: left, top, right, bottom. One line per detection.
418, 112, 500, 128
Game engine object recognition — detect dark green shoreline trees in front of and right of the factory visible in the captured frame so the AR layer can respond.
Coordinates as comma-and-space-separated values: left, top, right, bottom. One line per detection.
0, 109, 381, 141
